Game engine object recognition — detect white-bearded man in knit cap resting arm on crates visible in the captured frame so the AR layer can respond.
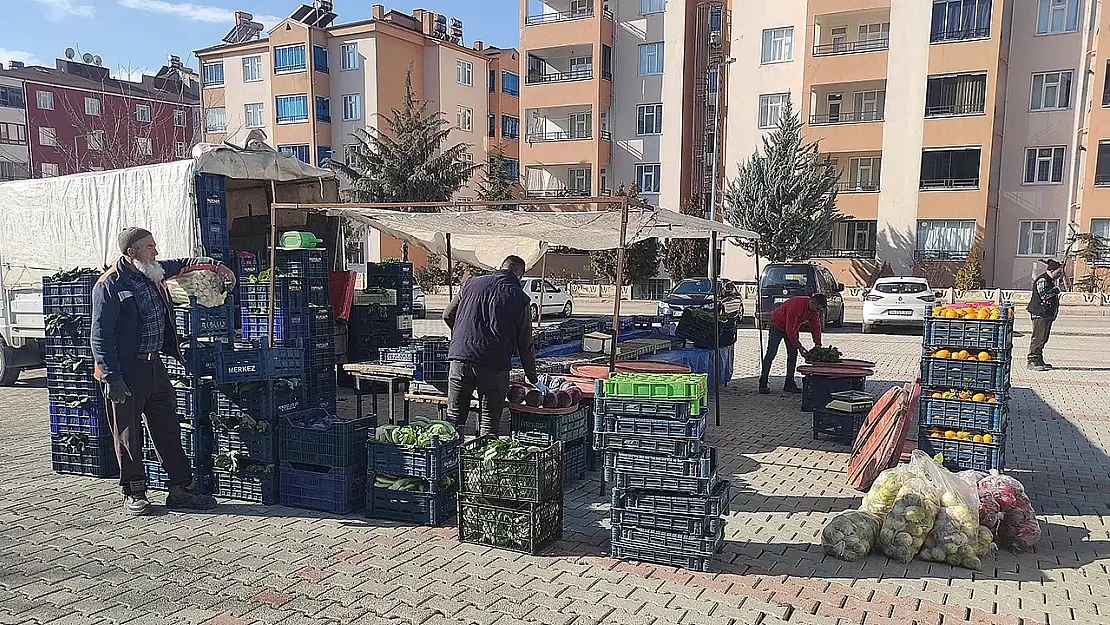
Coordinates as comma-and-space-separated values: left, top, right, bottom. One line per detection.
90, 228, 235, 516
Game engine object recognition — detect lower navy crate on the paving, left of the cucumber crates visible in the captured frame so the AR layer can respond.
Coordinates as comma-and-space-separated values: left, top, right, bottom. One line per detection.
279, 461, 366, 514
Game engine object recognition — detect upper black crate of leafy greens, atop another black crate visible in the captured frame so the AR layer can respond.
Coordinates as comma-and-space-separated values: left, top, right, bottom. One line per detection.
458, 436, 563, 502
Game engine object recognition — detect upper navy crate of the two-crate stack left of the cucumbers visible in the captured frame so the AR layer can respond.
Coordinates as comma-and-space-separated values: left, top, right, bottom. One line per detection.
280, 409, 377, 472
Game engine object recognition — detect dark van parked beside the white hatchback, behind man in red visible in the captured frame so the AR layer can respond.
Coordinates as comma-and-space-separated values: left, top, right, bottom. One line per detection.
756, 262, 844, 327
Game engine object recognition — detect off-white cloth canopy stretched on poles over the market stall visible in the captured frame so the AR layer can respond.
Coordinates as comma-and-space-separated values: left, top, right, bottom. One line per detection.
317, 205, 758, 269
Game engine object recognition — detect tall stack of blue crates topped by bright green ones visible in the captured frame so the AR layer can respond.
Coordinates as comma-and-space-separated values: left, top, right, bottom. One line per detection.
594, 373, 729, 571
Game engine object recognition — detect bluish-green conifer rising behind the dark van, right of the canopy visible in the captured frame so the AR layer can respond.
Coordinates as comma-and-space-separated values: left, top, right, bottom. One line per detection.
725, 100, 848, 262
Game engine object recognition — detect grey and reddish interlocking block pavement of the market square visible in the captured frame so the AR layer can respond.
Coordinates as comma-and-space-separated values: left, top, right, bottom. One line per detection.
0, 321, 1110, 625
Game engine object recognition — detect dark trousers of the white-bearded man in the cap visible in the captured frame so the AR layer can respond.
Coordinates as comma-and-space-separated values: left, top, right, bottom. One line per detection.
105, 360, 192, 494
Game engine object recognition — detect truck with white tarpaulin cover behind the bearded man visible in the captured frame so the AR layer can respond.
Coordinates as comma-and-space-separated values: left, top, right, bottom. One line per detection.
0, 144, 342, 386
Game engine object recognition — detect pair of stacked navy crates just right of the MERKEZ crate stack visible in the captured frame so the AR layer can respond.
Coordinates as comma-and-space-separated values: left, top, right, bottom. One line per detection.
279, 407, 377, 514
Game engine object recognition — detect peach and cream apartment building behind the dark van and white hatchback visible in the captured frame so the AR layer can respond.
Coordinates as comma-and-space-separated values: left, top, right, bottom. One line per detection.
725, 0, 1094, 288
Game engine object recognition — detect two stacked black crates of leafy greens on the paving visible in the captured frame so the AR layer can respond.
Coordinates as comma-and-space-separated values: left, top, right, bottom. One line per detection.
458, 436, 564, 554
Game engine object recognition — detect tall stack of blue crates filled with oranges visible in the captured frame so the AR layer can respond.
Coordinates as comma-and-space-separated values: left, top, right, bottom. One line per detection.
918, 303, 1013, 471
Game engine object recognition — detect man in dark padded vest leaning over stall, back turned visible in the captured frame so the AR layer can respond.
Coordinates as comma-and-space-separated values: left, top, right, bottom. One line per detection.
443, 256, 538, 436
